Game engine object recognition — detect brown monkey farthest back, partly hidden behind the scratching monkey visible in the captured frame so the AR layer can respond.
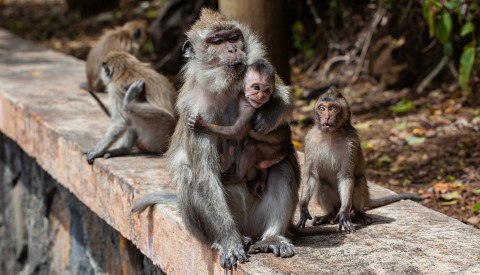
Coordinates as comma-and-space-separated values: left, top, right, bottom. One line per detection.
87, 20, 148, 92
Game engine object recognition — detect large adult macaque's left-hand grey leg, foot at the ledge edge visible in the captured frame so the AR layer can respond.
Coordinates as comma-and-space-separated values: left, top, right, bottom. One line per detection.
176, 165, 248, 269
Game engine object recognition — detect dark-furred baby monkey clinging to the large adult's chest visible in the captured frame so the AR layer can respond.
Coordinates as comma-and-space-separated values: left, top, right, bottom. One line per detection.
188, 59, 291, 196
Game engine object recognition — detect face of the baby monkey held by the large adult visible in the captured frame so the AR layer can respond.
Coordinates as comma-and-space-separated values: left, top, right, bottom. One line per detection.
245, 70, 274, 108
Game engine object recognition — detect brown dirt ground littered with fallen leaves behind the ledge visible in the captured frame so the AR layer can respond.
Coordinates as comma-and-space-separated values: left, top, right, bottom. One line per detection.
0, 0, 480, 228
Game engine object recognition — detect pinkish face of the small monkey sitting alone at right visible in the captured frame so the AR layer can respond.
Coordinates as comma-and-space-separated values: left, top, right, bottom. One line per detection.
315, 101, 345, 133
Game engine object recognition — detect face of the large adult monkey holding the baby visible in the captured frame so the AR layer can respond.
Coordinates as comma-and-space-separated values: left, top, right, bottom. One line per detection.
205, 28, 246, 71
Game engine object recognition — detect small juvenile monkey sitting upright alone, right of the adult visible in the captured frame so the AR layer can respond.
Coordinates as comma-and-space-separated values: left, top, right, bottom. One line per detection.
297, 88, 421, 233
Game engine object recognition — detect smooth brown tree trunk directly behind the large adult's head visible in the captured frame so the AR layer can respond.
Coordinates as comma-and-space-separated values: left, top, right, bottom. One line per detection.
218, 0, 290, 83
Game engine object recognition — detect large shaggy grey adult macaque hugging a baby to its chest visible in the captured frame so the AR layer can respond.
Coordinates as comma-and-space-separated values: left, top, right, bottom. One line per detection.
131, 9, 298, 269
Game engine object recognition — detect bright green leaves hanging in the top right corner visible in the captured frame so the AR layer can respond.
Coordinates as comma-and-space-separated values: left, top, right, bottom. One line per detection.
423, 0, 480, 91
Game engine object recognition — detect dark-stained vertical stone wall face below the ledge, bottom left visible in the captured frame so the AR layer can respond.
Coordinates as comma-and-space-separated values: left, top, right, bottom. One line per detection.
0, 133, 162, 274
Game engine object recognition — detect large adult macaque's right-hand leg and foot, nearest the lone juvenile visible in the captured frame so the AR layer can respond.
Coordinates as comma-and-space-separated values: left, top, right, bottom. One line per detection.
248, 160, 298, 258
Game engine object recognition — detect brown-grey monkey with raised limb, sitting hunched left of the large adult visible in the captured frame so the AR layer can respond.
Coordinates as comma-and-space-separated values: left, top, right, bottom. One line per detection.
85, 50, 176, 164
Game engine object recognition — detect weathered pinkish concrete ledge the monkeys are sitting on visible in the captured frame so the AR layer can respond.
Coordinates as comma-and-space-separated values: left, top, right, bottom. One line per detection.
0, 31, 480, 274
